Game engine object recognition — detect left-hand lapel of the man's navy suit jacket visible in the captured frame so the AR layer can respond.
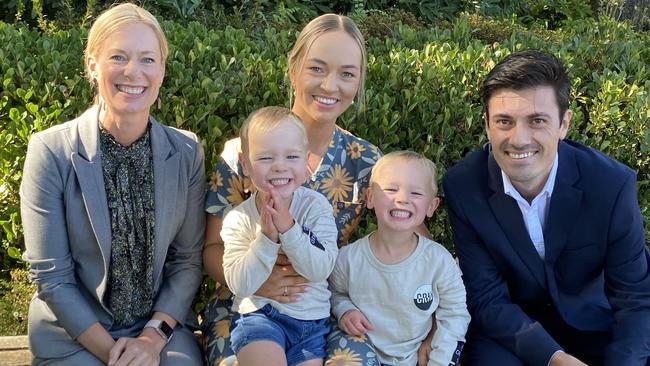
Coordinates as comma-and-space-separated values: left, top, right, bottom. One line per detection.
488, 153, 546, 288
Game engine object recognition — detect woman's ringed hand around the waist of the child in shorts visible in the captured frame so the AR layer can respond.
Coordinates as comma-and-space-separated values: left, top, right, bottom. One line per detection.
255, 254, 309, 304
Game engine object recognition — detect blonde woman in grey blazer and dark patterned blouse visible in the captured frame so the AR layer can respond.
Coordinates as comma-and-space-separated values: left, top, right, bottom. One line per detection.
20, 4, 204, 366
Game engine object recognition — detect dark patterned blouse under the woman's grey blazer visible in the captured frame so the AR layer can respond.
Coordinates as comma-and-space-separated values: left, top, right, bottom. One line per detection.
100, 123, 155, 326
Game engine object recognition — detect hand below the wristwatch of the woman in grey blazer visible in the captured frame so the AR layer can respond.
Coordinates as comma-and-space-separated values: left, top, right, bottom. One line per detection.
108, 328, 167, 366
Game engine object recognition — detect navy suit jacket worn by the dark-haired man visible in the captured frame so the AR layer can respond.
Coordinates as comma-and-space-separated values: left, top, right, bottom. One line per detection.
443, 141, 650, 366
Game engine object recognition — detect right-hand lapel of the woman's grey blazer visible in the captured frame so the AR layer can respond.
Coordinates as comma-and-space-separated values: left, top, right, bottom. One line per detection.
151, 118, 178, 288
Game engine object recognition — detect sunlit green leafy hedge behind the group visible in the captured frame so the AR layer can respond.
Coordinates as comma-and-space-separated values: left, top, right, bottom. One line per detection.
0, 15, 650, 269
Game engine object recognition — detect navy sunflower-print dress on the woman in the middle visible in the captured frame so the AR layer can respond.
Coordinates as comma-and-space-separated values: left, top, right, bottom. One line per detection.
203, 126, 381, 365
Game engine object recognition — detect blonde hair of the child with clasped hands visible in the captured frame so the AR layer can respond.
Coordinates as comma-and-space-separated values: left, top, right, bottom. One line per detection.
239, 107, 308, 159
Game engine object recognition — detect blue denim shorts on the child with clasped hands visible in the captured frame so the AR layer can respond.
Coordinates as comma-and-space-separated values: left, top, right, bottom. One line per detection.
230, 305, 330, 366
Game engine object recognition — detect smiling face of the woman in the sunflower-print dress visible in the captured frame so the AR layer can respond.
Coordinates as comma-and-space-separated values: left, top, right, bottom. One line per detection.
290, 30, 362, 129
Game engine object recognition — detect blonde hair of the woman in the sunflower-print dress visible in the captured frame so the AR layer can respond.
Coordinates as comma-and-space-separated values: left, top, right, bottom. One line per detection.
287, 14, 367, 110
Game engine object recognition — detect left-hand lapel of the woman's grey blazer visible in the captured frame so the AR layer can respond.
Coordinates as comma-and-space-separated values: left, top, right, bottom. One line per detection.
72, 107, 111, 299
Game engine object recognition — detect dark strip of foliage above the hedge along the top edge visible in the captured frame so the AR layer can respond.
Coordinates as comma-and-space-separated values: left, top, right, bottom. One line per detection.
0, 0, 584, 29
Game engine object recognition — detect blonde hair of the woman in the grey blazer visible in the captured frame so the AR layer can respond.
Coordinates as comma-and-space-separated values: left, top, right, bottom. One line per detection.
84, 3, 169, 83
